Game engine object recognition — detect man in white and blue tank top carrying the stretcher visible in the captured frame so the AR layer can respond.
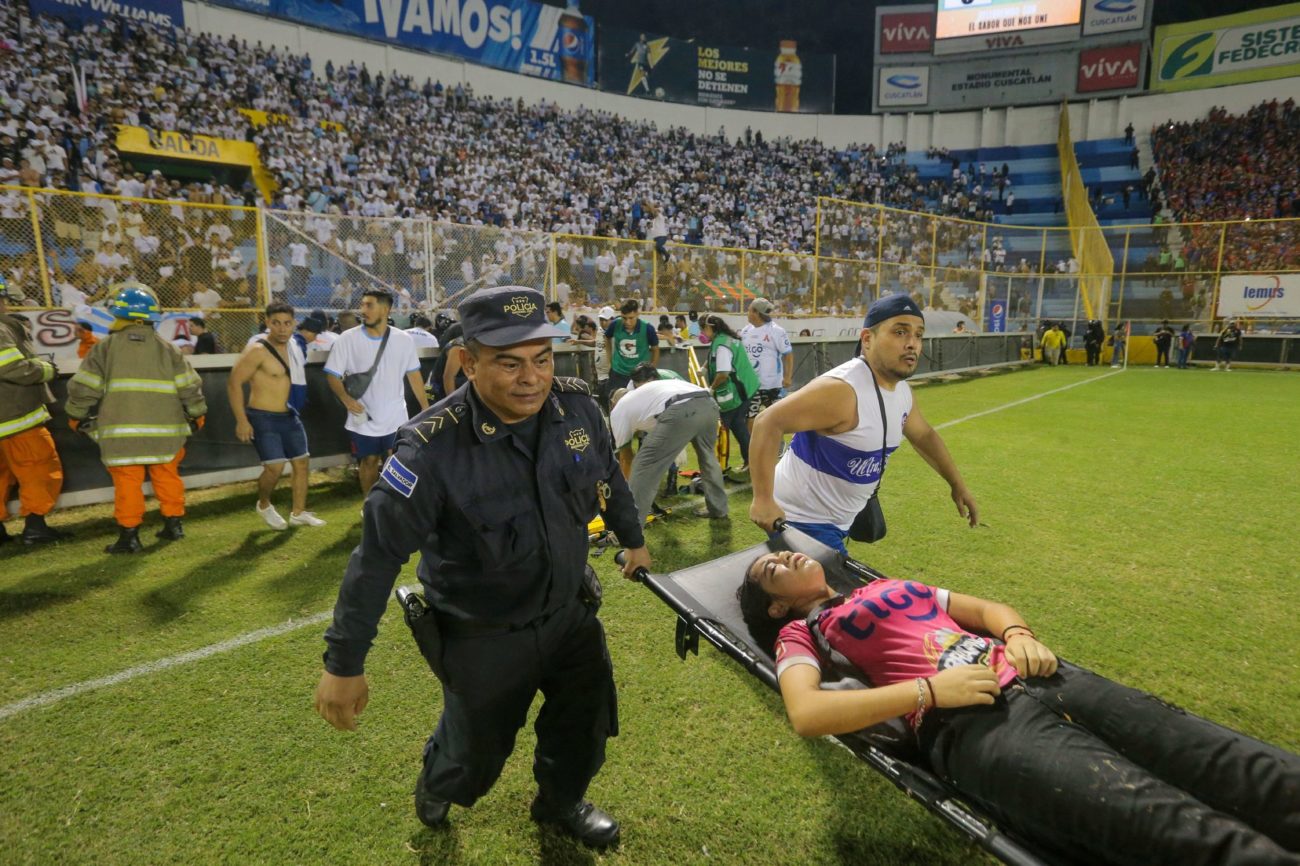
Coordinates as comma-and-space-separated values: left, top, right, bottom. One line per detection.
749, 294, 979, 551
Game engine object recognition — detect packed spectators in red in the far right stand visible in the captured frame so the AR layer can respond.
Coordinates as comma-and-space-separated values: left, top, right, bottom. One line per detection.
1151, 99, 1300, 270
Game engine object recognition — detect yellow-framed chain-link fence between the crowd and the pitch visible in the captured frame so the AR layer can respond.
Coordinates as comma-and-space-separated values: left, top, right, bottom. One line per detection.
0, 186, 1300, 346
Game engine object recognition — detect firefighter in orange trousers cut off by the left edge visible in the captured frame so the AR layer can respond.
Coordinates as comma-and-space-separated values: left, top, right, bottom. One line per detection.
0, 278, 68, 545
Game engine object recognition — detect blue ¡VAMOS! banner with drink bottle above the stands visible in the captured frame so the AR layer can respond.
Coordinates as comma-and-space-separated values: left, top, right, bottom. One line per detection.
208, 0, 595, 87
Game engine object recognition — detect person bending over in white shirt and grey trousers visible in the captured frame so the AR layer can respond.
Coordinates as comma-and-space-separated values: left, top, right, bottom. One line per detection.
610, 364, 728, 523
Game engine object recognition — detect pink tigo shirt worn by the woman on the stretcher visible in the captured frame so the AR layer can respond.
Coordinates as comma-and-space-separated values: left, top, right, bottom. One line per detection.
776, 580, 1017, 723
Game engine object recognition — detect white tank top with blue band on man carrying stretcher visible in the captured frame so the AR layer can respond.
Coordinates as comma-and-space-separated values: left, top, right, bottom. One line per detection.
774, 358, 911, 529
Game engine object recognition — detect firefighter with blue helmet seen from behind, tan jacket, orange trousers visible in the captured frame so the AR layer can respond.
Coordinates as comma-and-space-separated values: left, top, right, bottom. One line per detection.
65, 282, 208, 553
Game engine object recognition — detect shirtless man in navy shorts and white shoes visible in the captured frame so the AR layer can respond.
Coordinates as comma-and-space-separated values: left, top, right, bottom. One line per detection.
226, 302, 325, 529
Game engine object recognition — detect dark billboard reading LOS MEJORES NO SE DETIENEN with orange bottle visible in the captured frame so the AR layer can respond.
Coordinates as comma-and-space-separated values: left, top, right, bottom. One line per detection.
599, 26, 835, 114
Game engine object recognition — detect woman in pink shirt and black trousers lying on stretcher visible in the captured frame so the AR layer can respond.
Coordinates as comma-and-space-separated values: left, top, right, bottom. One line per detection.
737, 550, 1300, 865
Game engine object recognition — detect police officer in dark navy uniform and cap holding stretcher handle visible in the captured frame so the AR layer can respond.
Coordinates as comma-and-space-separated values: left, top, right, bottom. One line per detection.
316, 286, 650, 846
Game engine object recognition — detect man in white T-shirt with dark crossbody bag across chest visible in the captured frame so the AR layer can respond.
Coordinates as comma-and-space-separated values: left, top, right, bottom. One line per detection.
325, 289, 429, 497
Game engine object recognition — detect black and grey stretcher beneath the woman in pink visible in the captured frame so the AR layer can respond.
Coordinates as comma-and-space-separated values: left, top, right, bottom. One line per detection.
624, 528, 1063, 866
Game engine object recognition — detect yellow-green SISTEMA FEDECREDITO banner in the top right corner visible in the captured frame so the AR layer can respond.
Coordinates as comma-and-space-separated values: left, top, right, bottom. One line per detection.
1151, 3, 1300, 91
